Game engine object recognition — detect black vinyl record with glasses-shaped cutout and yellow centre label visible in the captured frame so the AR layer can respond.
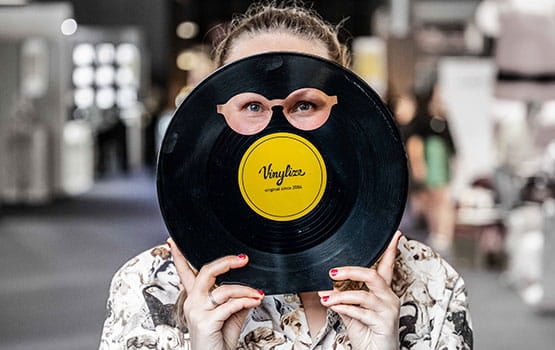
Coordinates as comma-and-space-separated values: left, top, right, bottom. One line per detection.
157, 53, 408, 294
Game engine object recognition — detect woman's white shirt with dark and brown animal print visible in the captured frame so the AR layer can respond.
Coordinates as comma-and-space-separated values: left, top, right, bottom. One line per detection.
100, 237, 473, 350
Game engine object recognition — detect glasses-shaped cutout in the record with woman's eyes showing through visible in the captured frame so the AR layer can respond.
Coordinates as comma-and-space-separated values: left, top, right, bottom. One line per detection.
217, 88, 337, 135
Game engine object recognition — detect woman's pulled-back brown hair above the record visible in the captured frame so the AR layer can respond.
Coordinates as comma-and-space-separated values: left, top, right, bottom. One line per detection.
214, 1, 351, 66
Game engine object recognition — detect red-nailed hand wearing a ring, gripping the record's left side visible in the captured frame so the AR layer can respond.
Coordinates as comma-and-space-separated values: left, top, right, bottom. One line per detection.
168, 239, 264, 350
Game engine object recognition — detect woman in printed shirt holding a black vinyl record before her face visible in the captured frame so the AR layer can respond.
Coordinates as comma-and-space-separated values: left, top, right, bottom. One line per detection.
100, 4, 472, 350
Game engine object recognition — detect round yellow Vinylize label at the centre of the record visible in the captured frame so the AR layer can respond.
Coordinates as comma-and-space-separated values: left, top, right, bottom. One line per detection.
238, 132, 327, 221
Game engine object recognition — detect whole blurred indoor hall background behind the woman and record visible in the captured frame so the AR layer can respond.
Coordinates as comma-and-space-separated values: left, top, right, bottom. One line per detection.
0, 0, 555, 350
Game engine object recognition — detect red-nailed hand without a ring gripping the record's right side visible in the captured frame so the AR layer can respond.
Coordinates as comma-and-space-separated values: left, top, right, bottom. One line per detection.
319, 231, 401, 350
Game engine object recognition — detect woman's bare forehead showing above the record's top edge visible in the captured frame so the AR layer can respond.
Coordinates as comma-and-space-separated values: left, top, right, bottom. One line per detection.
224, 32, 330, 64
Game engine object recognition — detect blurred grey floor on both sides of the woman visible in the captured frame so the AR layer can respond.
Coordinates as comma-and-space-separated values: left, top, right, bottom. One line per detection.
0, 171, 555, 350
